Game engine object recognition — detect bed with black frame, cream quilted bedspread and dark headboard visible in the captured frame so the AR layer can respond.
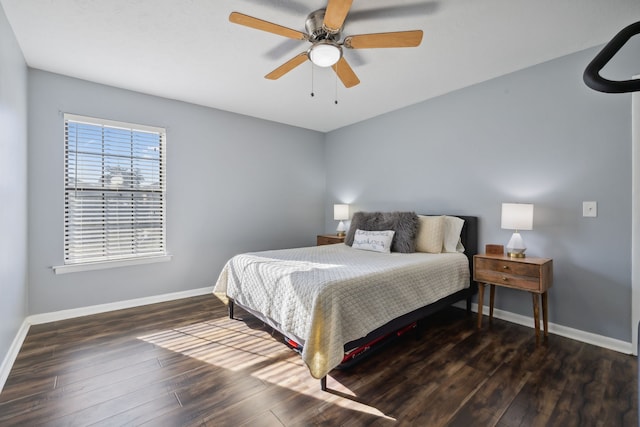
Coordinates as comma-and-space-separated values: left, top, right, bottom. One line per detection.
214, 213, 477, 390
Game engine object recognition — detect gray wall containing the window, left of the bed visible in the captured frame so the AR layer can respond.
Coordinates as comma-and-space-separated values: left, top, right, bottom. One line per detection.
28, 70, 325, 313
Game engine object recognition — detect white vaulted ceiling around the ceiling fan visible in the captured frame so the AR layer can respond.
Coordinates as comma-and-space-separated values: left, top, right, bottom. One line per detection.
0, 0, 640, 132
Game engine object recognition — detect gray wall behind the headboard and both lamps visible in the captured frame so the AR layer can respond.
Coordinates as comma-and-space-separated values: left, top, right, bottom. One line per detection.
325, 45, 640, 341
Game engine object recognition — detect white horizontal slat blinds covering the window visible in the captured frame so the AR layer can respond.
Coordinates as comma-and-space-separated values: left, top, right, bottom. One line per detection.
64, 114, 166, 265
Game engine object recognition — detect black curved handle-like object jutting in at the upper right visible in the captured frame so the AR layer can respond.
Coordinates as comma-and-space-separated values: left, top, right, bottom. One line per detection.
583, 22, 640, 93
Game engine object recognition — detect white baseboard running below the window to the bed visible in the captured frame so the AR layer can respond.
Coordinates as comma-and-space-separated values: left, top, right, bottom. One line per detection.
27, 287, 213, 325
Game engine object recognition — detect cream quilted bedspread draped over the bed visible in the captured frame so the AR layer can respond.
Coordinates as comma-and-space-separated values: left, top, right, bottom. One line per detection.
214, 244, 469, 378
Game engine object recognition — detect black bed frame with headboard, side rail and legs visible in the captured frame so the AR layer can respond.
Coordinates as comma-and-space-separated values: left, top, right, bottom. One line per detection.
229, 215, 478, 391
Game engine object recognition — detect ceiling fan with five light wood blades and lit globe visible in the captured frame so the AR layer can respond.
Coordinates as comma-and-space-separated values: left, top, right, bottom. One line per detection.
229, 0, 422, 88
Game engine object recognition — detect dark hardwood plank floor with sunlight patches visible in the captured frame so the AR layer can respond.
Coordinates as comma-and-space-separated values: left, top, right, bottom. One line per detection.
0, 295, 638, 427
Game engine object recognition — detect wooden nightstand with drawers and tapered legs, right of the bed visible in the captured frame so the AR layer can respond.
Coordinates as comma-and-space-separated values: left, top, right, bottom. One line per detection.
473, 255, 553, 342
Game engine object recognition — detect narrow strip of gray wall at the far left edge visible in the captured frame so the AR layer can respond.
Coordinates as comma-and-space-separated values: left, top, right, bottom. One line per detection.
0, 2, 28, 368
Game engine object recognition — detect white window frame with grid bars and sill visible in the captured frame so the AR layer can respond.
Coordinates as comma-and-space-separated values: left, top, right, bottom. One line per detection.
52, 113, 171, 274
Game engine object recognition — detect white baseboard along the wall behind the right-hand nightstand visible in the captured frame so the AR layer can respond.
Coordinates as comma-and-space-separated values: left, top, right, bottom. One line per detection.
456, 303, 633, 354
